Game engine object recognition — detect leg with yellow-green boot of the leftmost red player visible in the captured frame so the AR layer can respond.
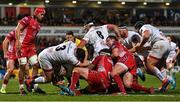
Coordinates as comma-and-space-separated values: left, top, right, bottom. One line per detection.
0, 59, 15, 93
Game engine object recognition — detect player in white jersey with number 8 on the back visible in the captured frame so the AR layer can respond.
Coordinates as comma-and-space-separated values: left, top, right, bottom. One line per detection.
78, 22, 120, 57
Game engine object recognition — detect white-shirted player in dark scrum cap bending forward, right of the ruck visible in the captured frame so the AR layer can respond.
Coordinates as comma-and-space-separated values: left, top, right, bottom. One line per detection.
135, 21, 170, 92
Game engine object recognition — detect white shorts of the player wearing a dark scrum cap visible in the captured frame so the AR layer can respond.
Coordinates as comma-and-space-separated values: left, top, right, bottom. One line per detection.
149, 40, 170, 59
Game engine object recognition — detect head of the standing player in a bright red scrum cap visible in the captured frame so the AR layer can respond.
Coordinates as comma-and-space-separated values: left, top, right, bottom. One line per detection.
34, 7, 46, 22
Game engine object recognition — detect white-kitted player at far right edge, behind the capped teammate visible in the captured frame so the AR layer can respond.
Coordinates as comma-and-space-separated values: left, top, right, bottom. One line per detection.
166, 36, 180, 89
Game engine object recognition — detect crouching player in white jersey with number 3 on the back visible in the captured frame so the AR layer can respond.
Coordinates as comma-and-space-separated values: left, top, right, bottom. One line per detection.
25, 41, 88, 92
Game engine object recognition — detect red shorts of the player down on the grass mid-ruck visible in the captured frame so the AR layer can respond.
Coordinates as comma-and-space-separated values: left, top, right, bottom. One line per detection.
87, 70, 110, 91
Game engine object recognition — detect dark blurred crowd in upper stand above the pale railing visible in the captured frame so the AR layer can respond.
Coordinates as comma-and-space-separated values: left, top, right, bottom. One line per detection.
0, 9, 180, 26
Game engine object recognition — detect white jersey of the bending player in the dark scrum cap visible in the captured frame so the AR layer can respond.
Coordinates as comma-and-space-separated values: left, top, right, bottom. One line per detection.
139, 24, 167, 45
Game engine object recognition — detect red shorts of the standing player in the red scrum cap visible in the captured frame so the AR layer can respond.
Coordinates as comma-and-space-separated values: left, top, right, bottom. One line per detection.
19, 45, 36, 57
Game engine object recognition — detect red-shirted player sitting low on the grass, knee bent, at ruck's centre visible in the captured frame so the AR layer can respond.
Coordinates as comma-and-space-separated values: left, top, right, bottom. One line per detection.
61, 49, 113, 95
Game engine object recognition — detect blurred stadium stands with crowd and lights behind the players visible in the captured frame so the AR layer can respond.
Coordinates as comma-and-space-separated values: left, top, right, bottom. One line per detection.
0, 0, 180, 100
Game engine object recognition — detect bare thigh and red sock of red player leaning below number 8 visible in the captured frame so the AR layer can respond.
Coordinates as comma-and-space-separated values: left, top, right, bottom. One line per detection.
111, 62, 128, 93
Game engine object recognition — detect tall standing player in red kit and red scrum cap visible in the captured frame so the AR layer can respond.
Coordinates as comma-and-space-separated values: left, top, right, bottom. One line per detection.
15, 7, 45, 95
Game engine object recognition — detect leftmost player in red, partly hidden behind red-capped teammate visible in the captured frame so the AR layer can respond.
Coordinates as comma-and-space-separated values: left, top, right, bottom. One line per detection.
0, 31, 29, 93
